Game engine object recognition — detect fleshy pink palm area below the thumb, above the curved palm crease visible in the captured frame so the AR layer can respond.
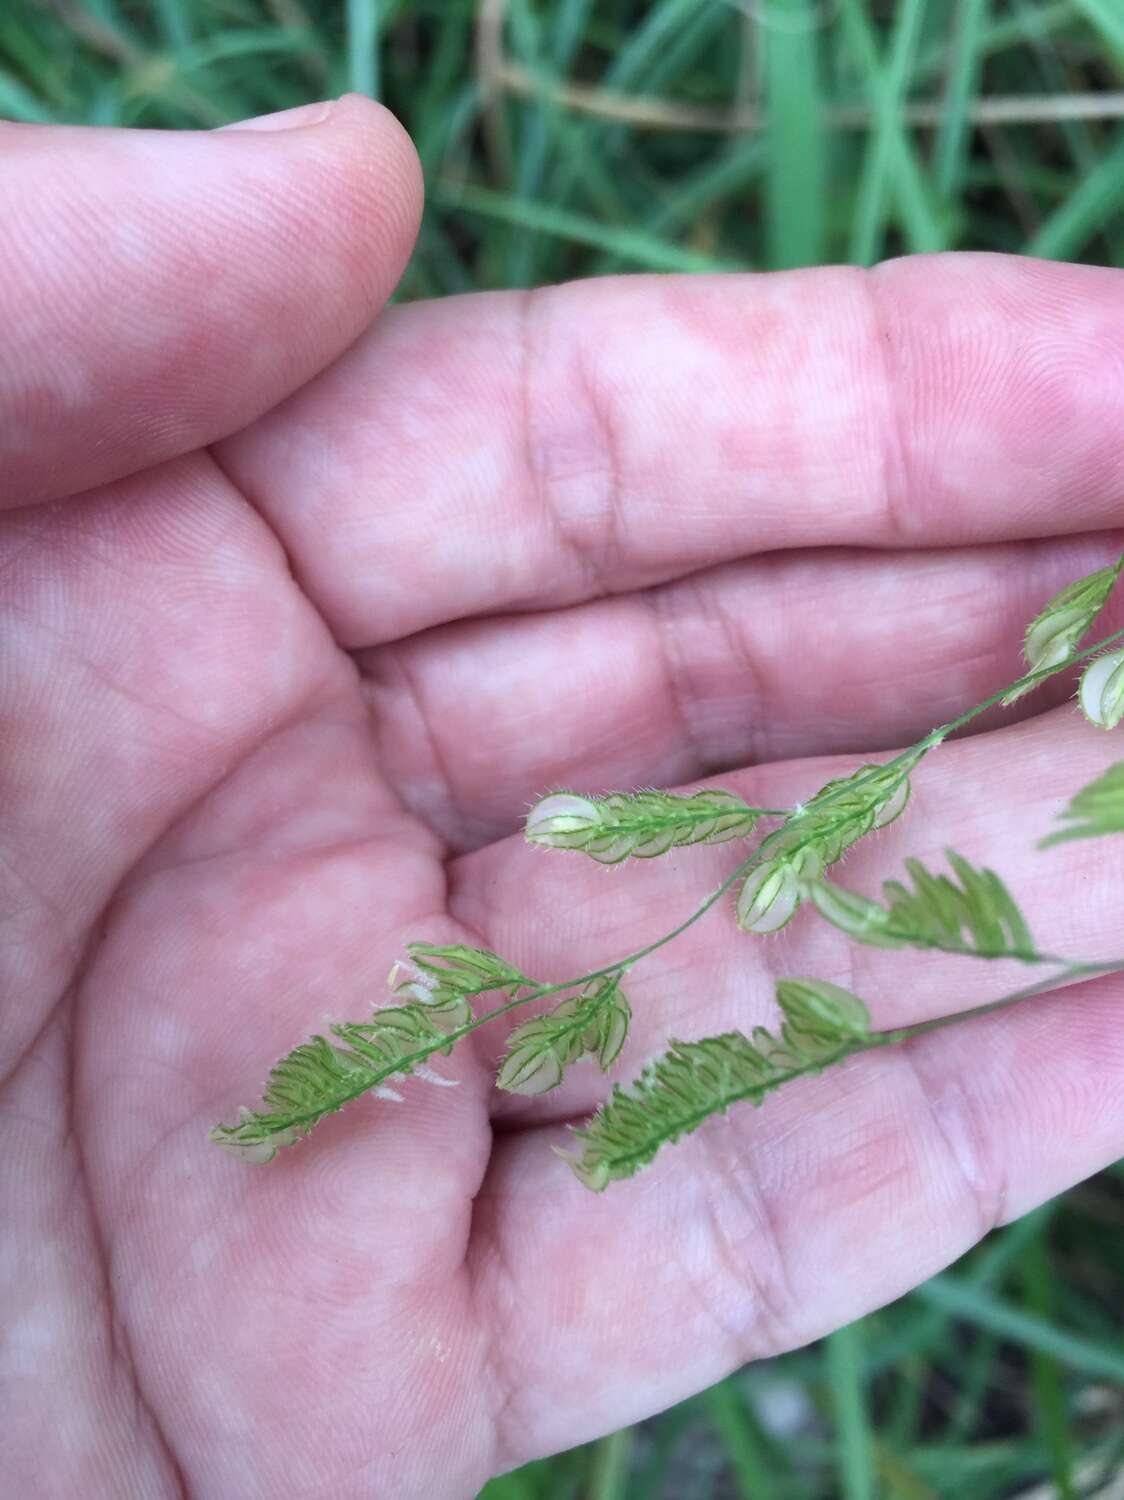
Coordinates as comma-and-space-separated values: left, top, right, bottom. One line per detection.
0, 455, 359, 1076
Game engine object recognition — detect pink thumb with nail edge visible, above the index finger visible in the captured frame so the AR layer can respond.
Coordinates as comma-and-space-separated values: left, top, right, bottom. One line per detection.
0, 98, 420, 506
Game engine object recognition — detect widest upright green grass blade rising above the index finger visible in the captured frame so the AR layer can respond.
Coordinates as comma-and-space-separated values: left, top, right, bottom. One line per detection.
761, 0, 824, 270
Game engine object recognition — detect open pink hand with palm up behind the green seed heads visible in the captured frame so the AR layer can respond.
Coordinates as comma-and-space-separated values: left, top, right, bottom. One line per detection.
0, 101, 1124, 1500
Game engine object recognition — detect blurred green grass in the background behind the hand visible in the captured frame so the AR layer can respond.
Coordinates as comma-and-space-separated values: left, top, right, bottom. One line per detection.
0, 0, 1124, 1500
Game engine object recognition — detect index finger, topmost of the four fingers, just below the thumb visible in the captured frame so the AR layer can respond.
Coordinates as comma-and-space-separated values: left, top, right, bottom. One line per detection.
222, 255, 1124, 647
